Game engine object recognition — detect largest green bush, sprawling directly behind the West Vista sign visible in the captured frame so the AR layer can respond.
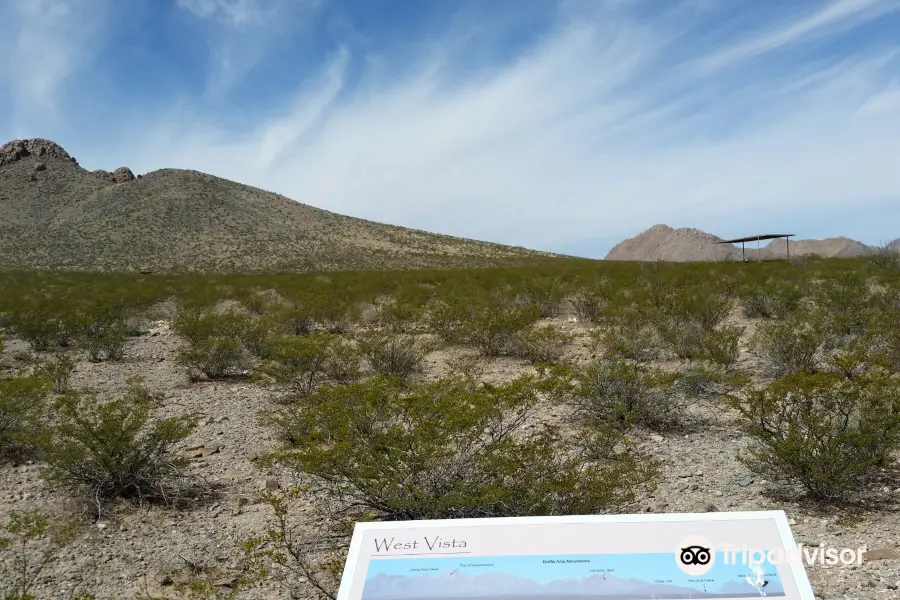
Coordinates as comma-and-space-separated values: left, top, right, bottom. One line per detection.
264, 378, 655, 520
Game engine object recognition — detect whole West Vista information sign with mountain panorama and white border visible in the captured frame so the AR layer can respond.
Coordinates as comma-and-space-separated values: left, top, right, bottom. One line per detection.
337, 511, 814, 600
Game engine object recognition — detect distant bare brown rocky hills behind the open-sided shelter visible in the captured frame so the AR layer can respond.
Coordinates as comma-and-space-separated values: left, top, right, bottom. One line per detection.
606, 225, 880, 262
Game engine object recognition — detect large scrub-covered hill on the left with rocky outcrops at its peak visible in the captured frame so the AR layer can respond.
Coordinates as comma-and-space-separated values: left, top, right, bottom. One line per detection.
0, 139, 554, 271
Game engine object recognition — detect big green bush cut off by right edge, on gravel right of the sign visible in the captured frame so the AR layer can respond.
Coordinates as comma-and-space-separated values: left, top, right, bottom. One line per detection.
731, 373, 900, 500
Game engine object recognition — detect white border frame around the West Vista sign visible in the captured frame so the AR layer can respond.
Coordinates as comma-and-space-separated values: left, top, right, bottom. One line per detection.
337, 510, 815, 600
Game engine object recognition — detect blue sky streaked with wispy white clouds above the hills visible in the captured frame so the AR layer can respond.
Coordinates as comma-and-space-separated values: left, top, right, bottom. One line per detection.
0, 0, 900, 257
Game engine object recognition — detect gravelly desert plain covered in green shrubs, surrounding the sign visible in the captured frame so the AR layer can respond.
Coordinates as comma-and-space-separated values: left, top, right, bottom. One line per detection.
0, 255, 900, 600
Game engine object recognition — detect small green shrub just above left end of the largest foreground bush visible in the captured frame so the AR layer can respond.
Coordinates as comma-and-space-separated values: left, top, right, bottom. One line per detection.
258, 334, 332, 394
